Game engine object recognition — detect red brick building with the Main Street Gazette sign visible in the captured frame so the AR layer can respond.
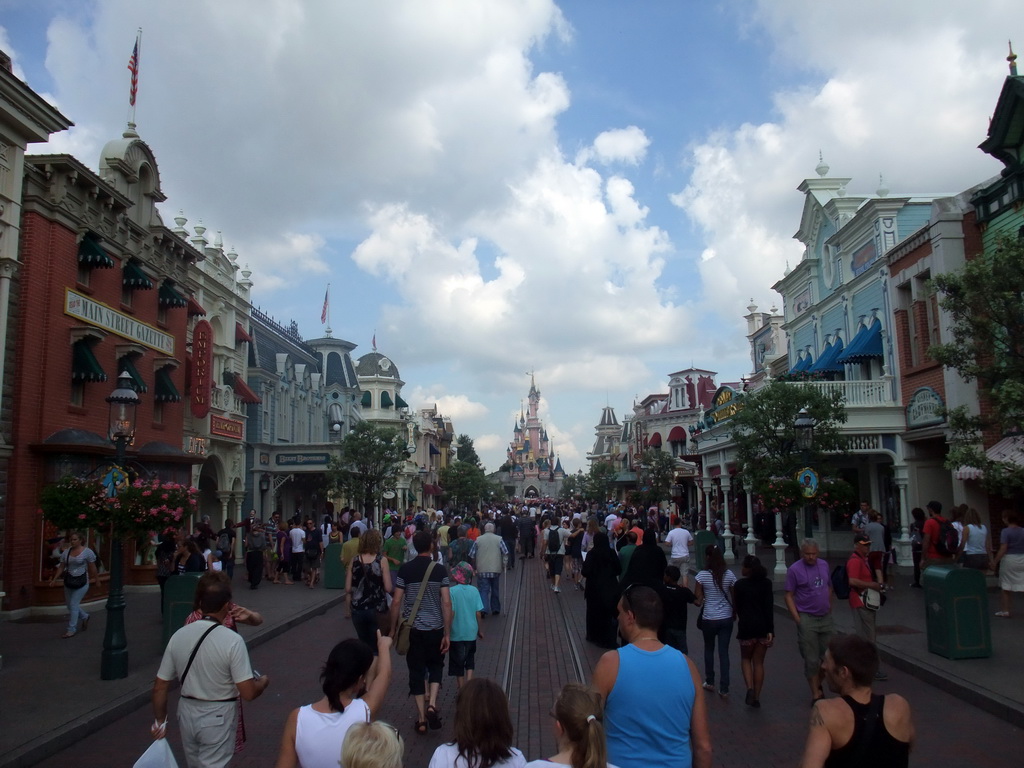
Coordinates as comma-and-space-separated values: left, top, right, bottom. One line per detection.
3, 125, 202, 611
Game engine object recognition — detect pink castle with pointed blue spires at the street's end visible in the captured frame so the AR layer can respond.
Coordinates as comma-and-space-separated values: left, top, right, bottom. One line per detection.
498, 374, 565, 499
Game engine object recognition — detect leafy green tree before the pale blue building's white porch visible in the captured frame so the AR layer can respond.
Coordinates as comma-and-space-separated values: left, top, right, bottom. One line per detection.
729, 382, 847, 494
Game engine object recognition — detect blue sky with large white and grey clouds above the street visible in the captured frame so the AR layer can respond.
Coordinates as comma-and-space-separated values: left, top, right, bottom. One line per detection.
0, 0, 1024, 471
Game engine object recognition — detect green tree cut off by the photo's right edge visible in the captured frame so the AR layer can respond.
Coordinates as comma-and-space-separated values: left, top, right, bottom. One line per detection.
928, 238, 1024, 496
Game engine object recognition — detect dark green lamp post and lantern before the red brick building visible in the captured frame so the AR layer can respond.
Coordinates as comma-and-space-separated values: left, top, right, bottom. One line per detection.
99, 371, 138, 680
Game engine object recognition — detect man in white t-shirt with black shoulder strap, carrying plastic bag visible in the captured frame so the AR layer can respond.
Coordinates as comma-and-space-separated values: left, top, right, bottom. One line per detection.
150, 583, 270, 768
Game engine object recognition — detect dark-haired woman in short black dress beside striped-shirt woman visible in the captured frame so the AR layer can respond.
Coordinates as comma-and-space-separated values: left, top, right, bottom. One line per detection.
735, 555, 775, 707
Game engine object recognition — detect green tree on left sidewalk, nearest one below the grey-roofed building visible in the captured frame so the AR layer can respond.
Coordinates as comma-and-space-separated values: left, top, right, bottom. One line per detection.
327, 421, 409, 515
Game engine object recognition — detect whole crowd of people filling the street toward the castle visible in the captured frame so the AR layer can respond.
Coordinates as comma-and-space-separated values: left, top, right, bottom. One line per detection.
54, 502, 1024, 768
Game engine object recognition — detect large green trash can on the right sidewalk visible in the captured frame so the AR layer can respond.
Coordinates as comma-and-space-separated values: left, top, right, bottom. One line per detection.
922, 565, 992, 658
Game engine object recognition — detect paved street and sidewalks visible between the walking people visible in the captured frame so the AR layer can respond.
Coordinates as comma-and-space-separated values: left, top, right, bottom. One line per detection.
0, 548, 1024, 768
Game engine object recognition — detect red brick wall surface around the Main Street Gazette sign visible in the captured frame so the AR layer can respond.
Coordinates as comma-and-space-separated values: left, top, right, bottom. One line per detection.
4, 211, 187, 609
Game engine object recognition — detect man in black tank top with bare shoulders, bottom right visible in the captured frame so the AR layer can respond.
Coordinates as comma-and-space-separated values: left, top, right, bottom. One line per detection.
800, 635, 914, 768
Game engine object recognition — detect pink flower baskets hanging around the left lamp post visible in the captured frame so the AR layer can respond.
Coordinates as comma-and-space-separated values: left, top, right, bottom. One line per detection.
40, 475, 198, 538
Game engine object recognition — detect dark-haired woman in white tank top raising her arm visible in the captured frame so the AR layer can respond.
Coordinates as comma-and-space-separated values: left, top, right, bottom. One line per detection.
274, 632, 391, 768
